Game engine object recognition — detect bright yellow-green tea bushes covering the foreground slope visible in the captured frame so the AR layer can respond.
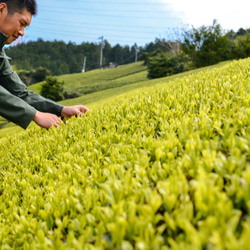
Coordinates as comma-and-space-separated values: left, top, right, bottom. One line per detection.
0, 59, 250, 249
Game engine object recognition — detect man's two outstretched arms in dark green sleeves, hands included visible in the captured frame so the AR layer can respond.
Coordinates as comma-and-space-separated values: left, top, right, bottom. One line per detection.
0, 53, 88, 128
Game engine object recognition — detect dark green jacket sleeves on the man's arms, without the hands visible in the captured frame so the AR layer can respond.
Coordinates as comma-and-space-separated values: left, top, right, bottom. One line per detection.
0, 51, 63, 128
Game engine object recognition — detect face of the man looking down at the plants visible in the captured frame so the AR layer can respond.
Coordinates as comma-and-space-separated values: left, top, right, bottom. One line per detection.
0, 4, 32, 44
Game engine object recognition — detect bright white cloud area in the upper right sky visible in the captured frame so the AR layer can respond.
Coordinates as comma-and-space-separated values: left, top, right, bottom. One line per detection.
151, 0, 250, 31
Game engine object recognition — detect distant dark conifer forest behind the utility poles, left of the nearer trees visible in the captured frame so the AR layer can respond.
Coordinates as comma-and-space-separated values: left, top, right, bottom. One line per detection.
6, 39, 142, 75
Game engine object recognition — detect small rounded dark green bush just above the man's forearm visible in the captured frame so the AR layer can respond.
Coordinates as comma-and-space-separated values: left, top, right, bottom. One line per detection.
41, 76, 65, 101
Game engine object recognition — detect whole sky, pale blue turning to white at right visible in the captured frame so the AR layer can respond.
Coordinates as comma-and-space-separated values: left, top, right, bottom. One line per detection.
22, 0, 250, 47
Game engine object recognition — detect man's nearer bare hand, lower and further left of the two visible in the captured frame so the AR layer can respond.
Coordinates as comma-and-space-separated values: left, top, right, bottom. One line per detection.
33, 111, 63, 129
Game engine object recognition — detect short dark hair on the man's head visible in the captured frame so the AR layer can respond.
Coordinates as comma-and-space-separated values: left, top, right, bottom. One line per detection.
0, 0, 37, 15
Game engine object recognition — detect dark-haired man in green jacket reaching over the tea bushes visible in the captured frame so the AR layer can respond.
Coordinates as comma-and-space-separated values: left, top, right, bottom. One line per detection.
0, 0, 88, 129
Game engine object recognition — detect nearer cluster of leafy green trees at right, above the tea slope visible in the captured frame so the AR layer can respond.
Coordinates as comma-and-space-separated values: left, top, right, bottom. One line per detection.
144, 20, 250, 78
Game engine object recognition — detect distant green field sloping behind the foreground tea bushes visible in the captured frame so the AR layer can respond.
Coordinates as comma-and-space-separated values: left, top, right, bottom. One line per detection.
0, 62, 229, 138
